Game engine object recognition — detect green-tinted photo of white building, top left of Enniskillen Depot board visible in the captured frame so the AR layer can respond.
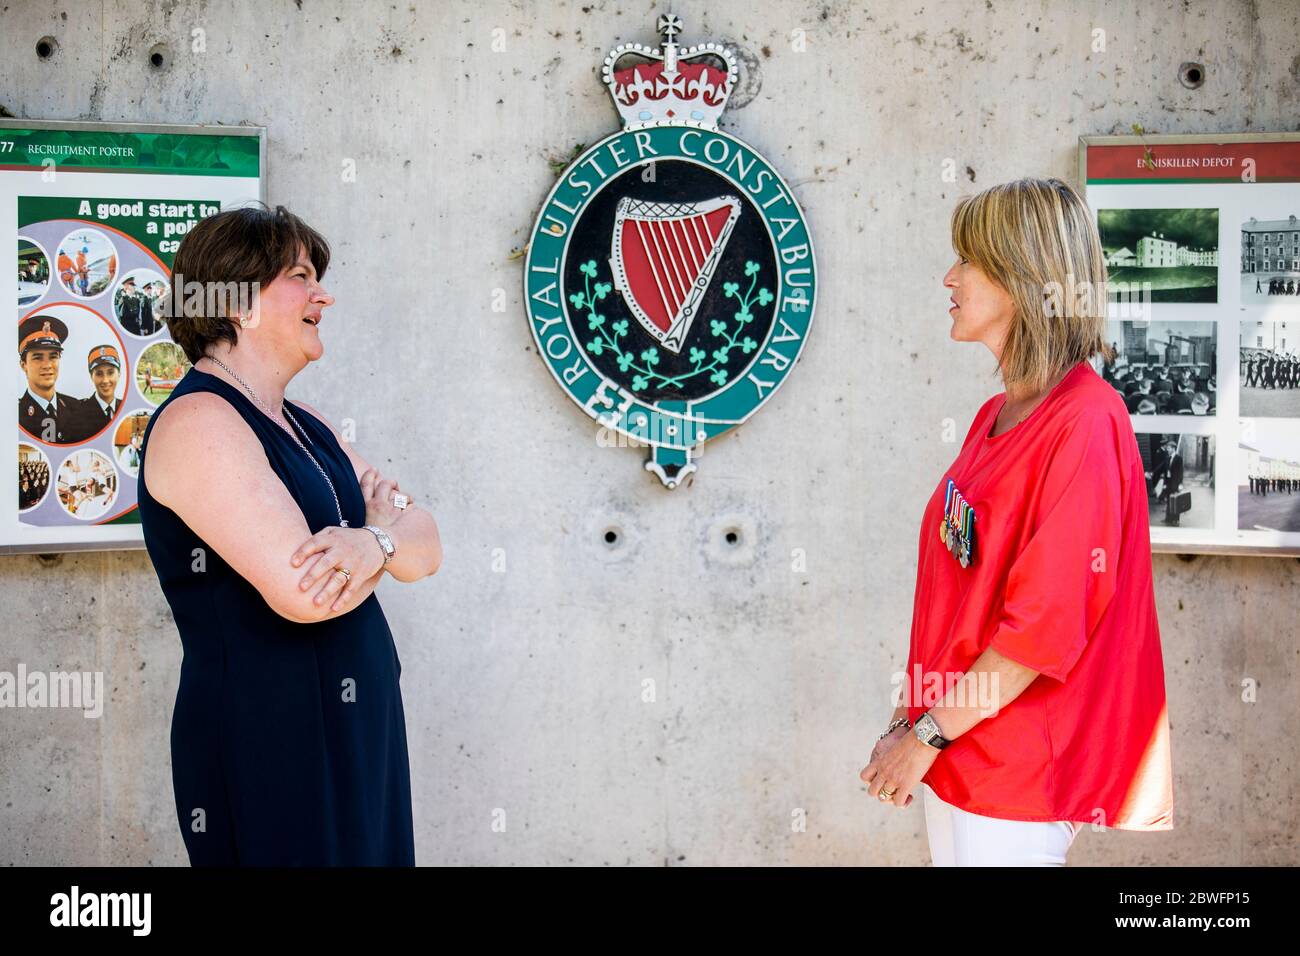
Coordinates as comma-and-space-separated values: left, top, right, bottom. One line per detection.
1097, 209, 1218, 302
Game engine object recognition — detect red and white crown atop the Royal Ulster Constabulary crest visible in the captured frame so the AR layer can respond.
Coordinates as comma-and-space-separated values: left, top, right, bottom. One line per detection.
601, 13, 737, 129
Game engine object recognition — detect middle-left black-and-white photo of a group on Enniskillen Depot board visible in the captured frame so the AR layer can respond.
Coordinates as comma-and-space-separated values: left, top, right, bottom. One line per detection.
1100, 320, 1218, 415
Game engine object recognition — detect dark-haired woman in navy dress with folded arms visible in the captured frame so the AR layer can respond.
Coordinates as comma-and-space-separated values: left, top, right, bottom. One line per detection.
139, 206, 442, 865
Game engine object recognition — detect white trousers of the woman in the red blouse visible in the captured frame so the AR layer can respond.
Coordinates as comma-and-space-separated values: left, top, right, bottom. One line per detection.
920, 783, 1083, 866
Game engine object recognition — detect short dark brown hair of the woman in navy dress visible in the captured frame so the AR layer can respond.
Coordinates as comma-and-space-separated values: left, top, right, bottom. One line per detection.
168, 203, 329, 363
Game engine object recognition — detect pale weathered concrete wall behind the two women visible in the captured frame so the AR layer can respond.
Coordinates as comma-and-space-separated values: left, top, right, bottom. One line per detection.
0, 0, 1300, 865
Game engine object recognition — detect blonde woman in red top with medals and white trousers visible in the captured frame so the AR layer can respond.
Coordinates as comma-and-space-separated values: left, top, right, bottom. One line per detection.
861, 179, 1173, 866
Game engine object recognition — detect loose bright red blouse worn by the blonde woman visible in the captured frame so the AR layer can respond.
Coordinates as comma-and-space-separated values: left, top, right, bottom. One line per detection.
902, 362, 1174, 830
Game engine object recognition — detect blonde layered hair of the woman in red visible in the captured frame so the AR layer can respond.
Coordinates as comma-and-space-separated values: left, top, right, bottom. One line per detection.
952, 178, 1114, 393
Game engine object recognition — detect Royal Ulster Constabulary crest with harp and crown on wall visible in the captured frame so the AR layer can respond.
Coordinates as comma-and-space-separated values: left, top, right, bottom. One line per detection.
524, 14, 816, 488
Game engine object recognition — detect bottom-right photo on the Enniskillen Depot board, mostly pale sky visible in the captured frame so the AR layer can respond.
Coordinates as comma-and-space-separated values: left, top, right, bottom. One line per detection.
1236, 419, 1300, 531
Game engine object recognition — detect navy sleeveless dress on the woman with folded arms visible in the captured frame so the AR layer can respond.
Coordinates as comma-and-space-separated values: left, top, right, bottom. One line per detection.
139, 368, 415, 866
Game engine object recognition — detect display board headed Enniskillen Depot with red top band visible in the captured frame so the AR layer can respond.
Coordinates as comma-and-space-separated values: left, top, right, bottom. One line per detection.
1079, 134, 1300, 554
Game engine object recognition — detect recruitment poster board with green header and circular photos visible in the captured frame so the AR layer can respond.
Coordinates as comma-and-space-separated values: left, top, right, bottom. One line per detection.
0, 120, 265, 551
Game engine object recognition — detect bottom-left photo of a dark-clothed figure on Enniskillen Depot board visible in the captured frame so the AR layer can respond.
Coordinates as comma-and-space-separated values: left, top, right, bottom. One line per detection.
1138, 432, 1214, 528
